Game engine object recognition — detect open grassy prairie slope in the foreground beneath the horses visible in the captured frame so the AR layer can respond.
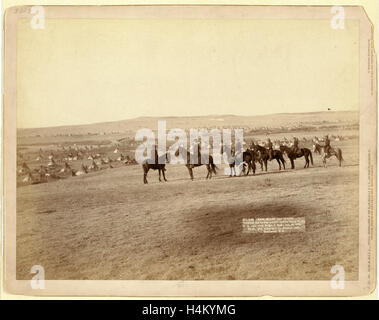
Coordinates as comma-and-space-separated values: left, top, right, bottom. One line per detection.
17, 138, 359, 280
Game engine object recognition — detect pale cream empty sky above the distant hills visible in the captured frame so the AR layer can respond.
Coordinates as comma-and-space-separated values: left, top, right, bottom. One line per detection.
17, 19, 359, 128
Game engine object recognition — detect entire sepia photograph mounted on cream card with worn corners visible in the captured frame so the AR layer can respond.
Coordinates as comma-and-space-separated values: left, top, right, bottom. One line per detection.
3, 6, 377, 297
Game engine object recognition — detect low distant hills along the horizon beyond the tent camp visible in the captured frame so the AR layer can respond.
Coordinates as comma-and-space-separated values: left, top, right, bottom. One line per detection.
17, 111, 359, 137
